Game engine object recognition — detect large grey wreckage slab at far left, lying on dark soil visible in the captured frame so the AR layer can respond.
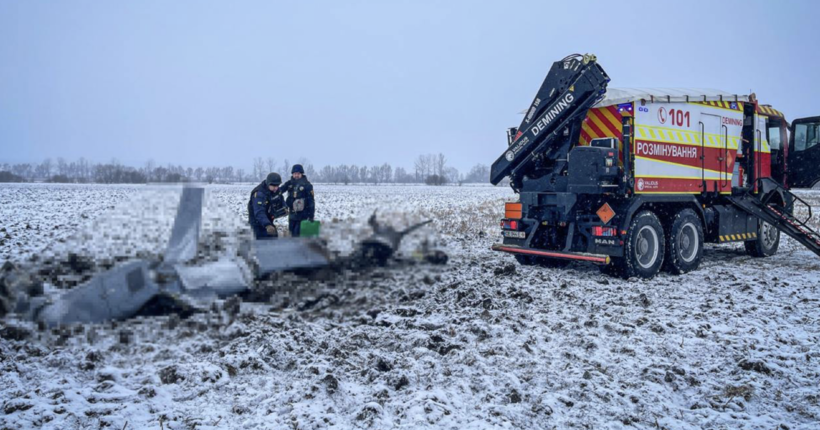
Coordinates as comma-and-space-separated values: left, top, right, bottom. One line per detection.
38, 260, 161, 327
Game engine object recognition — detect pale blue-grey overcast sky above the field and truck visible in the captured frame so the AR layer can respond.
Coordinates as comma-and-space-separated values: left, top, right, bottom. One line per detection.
0, 0, 820, 171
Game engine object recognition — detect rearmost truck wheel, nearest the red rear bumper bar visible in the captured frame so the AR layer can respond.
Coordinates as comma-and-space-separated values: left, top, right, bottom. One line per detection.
614, 211, 665, 279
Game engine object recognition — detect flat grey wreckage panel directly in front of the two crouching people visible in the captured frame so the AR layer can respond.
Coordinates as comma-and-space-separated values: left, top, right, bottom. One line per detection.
251, 237, 331, 278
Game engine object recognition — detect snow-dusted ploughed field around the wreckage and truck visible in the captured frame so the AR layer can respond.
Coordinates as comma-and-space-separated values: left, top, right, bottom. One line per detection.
0, 184, 820, 429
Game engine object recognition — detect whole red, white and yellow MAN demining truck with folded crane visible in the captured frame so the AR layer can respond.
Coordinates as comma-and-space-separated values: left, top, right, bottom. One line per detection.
490, 55, 820, 277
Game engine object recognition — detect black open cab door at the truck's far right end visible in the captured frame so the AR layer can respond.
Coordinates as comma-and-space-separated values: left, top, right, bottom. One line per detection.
786, 116, 820, 188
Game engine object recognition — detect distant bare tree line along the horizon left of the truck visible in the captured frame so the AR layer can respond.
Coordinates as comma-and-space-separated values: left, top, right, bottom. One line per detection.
0, 154, 490, 185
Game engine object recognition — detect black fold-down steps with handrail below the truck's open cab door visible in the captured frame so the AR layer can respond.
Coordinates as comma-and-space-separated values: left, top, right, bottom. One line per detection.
729, 178, 820, 256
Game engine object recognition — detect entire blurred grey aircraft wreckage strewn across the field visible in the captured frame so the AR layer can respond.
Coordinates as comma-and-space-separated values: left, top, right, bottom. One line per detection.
8, 186, 442, 327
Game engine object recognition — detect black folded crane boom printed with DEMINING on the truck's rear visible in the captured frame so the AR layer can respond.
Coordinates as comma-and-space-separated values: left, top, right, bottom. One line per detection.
490, 55, 609, 185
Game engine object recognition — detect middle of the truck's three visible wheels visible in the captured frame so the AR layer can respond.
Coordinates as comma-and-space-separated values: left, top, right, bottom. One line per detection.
664, 209, 703, 275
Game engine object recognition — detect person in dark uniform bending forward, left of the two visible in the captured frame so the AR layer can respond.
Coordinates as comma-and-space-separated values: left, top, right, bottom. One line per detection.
248, 173, 287, 240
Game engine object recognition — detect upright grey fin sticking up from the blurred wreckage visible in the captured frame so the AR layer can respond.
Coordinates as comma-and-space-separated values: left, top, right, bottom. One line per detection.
163, 186, 205, 267
